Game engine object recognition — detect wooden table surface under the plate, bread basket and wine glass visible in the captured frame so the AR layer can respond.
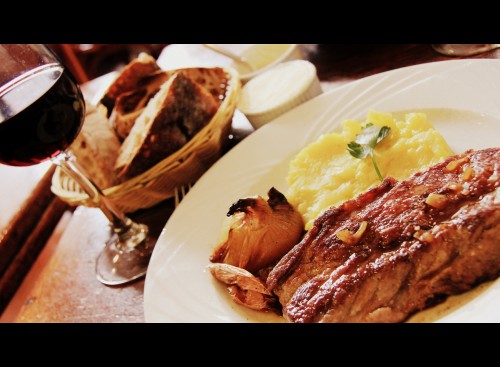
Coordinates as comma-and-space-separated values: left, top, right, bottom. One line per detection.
0, 44, 500, 322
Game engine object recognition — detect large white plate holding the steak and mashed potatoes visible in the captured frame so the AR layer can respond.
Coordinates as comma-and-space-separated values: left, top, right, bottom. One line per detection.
144, 60, 500, 322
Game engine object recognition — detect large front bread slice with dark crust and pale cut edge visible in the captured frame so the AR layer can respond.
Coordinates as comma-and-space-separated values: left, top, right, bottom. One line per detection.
115, 72, 219, 179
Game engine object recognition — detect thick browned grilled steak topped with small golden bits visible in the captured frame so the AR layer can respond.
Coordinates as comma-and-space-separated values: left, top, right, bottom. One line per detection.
267, 149, 500, 322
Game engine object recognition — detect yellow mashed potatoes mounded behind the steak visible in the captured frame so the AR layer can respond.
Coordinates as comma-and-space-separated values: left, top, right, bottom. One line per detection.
286, 111, 454, 229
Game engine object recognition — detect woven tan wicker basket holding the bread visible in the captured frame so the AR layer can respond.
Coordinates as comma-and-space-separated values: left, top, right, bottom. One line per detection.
51, 68, 241, 212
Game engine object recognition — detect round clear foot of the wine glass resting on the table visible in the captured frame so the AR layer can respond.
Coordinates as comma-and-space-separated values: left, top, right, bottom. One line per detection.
96, 224, 154, 285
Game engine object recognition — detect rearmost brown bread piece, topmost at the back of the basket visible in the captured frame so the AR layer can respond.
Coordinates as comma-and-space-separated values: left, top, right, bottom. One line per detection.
100, 52, 160, 116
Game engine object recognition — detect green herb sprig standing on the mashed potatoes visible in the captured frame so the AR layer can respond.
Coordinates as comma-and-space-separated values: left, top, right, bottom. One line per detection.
347, 123, 391, 181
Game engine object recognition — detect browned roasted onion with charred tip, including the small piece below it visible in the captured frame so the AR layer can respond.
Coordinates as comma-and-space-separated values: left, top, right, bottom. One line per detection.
208, 187, 304, 312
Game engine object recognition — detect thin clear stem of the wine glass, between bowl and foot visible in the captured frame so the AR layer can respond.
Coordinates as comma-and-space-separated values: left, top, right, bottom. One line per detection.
53, 151, 133, 236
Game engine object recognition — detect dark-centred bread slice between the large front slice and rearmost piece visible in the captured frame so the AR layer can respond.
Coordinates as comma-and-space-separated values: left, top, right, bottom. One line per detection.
109, 70, 171, 141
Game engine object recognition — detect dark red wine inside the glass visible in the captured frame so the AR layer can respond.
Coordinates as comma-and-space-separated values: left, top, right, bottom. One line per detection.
0, 64, 85, 166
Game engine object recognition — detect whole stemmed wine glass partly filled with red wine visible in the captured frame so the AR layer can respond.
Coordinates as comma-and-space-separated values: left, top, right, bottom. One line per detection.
0, 44, 154, 285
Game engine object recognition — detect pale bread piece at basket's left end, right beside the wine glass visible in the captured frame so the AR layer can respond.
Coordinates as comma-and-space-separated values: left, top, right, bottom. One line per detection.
70, 102, 120, 189
